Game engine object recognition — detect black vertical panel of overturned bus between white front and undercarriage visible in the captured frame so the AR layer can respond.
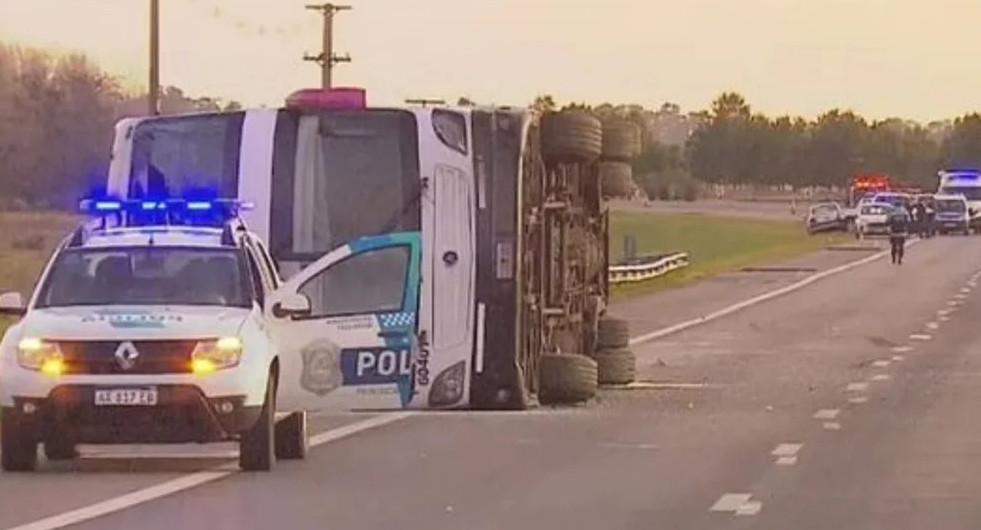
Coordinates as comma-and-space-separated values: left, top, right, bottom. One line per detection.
471, 111, 520, 407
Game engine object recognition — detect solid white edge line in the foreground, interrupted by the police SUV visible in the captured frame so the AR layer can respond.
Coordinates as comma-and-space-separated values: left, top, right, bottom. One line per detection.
4, 412, 412, 530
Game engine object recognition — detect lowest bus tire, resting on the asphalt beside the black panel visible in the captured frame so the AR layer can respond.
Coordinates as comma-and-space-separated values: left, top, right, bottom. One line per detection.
539, 353, 599, 405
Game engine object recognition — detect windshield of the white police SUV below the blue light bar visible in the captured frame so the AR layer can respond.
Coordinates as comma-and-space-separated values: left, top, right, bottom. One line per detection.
35, 247, 252, 308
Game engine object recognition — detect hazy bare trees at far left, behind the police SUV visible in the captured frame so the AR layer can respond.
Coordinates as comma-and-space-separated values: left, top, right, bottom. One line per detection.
0, 43, 241, 209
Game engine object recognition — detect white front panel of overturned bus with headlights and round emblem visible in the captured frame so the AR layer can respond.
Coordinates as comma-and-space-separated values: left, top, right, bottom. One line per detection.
414, 109, 477, 408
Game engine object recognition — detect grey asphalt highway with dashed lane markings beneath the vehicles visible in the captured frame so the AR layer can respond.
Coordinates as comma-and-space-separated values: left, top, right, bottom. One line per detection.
0, 237, 981, 530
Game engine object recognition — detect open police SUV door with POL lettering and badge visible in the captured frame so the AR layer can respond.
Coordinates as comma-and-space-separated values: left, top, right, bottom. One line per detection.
265, 232, 421, 410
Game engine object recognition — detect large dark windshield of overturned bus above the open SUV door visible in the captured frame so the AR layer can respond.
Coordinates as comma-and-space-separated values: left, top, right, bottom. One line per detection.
270, 110, 421, 264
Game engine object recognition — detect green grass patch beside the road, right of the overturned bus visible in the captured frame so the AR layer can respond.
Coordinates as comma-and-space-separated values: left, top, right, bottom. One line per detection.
610, 212, 848, 298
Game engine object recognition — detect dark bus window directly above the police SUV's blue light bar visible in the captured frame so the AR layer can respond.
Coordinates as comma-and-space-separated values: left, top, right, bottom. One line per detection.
128, 112, 245, 197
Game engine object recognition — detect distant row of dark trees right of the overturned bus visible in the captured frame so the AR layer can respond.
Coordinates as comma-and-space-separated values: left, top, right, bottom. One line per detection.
534, 92, 981, 198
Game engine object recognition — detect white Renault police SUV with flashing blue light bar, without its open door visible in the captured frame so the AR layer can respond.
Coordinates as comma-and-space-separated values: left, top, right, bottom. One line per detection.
0, 200, 317, 471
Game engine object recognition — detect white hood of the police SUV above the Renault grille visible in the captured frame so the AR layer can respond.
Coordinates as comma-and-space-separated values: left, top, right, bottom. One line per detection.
22, 306, 250, 340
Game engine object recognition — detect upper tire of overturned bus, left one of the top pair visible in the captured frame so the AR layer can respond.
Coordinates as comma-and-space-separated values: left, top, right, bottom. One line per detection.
541, 110, 603, 164
